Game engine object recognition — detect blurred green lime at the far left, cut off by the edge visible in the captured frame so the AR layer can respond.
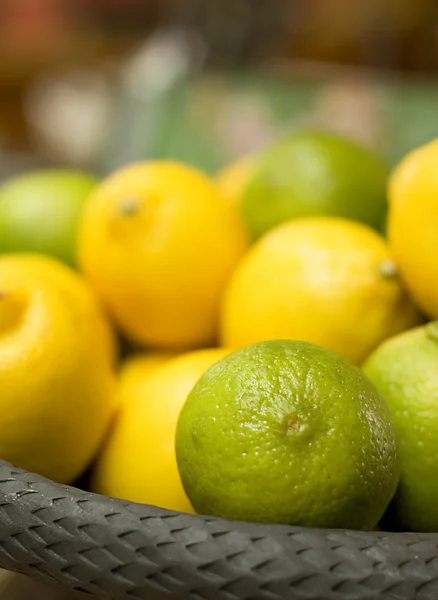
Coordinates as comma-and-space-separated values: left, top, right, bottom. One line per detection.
0, 170, 98, 265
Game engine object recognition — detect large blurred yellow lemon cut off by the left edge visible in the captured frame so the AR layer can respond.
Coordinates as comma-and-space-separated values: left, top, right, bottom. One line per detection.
0, 255, 116, 483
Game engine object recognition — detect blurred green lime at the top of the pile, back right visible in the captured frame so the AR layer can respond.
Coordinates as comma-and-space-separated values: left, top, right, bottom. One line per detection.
242, 131, 388, 237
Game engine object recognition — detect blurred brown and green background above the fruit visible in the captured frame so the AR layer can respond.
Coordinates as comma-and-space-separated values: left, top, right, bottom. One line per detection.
0, 0, 438, 176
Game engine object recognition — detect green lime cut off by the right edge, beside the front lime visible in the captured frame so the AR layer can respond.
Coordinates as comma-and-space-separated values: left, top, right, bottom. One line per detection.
363, 323, 438, 532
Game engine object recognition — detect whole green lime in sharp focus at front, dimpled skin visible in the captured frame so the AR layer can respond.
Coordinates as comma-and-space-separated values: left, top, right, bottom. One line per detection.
176, 340, 399, 530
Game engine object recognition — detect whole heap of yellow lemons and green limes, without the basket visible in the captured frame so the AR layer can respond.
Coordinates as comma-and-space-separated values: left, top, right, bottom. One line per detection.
0, 131, 438, 531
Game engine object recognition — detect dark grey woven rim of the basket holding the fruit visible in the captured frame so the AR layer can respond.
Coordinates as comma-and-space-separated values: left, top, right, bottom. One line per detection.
0, 461, 438, 600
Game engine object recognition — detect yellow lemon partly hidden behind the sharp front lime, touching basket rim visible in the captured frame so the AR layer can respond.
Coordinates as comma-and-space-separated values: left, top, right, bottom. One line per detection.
92, 349, 230, 512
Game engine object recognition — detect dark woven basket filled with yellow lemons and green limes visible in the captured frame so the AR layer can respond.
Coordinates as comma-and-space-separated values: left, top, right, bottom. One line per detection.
0, 130, 438, 600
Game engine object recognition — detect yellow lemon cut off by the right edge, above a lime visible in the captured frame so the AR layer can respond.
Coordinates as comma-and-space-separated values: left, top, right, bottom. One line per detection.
388, 140, 438, 319
